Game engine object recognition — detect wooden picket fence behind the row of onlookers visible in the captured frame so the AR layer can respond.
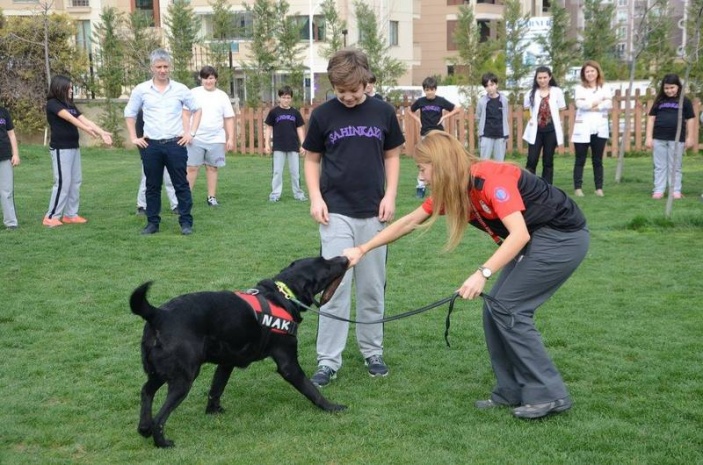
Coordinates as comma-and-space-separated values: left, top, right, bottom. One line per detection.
234, 91, 703, 157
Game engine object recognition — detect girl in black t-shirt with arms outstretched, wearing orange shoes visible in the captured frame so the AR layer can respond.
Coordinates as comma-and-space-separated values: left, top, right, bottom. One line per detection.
42, 75, 112, 228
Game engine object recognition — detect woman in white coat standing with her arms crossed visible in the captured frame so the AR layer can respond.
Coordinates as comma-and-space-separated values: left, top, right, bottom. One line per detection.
571, 61, 613, 197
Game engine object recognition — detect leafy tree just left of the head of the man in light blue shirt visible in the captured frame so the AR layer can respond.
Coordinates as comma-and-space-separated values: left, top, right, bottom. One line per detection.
125, 11, 161, 86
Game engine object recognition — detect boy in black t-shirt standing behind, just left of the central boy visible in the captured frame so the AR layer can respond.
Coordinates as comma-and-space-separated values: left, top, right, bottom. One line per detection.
264, 86, 307, 202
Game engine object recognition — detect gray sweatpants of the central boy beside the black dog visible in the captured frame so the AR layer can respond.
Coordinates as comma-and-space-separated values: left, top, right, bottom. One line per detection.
317, 214, 386, 371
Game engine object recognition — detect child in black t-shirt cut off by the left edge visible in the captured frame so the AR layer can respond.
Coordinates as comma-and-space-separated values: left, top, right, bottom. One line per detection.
0, 107, 20, 229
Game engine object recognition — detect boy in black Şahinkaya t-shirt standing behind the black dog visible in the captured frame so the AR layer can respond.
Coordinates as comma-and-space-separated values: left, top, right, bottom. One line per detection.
303, 49, 404, 386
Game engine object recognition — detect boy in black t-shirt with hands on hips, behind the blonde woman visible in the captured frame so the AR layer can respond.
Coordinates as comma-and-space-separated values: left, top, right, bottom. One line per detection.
410, 77, 459, 199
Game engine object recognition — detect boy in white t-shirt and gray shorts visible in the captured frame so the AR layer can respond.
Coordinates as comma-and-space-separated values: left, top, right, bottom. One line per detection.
188, 66, 234, 207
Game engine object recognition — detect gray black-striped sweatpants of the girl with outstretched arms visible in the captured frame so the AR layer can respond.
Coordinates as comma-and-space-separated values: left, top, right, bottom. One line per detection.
46, 149, 83, 219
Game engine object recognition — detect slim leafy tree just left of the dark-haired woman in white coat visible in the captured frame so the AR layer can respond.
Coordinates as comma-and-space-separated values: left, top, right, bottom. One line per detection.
499, 0, 530, 99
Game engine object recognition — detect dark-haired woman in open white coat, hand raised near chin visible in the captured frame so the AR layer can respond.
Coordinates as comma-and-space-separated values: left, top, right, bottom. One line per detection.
522, 66, 566, 184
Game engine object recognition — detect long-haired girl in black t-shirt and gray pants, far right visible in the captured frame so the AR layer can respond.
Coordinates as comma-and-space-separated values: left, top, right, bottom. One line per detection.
645, 74, 696, 200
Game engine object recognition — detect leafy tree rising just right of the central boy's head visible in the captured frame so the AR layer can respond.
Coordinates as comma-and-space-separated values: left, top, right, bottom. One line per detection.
354, 0, 407, 90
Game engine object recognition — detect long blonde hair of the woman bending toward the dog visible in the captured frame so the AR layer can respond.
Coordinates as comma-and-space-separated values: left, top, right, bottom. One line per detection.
414, 131, 478, 250
